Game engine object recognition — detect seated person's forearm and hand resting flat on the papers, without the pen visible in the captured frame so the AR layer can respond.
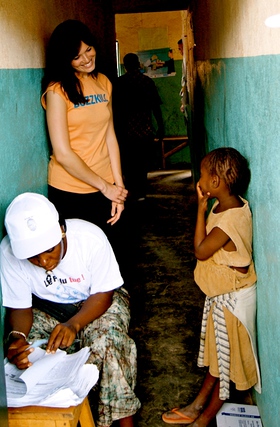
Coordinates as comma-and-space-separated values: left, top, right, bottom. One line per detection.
47, 291, 114, 352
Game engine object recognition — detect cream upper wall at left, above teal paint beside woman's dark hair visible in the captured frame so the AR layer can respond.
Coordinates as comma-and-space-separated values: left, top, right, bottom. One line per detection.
0, 0, 95, 69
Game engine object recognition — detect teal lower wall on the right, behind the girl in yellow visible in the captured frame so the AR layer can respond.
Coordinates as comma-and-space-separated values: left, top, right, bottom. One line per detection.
199, 55, 280, 427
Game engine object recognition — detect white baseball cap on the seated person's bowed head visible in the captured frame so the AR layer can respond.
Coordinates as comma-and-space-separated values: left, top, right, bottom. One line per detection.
5, 193, 62, 259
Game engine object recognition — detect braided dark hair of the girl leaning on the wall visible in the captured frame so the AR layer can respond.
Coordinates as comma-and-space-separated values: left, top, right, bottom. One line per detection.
204, 147, 250, 195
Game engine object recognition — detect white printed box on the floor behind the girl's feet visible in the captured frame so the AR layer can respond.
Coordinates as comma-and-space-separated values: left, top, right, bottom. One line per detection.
216, 403, 262, 427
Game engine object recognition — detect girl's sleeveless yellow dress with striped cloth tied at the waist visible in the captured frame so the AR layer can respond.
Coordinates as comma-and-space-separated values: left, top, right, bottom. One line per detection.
194, 199, 261, 399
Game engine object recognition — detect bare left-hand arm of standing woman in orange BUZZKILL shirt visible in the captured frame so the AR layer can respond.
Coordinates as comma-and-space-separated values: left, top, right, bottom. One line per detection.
46, 91, 126, 203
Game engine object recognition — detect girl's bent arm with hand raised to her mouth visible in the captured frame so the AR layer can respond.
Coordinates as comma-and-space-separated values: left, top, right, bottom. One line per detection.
194, 183, 231, 261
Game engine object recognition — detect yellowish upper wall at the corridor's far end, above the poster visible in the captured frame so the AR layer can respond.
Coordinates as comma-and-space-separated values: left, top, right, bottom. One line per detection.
115, 11, 182, 60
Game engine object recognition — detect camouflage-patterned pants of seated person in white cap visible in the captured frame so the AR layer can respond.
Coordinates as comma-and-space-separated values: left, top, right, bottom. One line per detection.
28, 288, 141, 426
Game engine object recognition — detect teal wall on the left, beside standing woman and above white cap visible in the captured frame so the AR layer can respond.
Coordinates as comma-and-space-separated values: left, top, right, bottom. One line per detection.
0, 69, 49, 238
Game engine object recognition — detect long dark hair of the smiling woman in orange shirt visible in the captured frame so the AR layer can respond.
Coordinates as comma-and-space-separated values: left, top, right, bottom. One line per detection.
42, 19, 98, 104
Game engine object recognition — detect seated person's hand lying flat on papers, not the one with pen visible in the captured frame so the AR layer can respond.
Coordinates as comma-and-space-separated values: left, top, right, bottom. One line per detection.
46, 322, 77, 353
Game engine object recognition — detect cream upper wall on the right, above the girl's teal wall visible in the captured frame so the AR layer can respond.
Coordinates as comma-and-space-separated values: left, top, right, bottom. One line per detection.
196, 0, 280, 59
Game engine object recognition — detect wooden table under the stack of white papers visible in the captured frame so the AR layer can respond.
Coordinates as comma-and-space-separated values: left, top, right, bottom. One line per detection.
8, 397, 95, 427
